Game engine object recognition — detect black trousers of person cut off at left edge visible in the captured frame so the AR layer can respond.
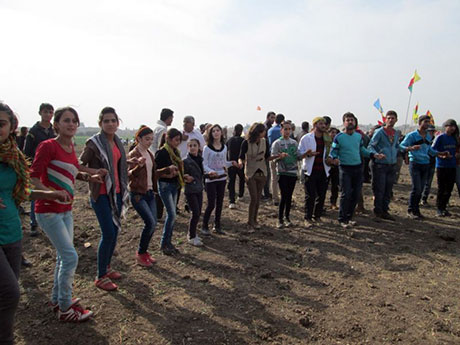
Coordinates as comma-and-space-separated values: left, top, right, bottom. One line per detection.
0, 241, 21, 344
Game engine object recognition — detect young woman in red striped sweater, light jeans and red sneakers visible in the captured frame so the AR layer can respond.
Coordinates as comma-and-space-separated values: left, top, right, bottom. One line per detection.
31, 107, 106, 322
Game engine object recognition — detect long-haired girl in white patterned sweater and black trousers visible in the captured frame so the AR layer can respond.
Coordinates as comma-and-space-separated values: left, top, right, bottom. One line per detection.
201, 125, 238, 236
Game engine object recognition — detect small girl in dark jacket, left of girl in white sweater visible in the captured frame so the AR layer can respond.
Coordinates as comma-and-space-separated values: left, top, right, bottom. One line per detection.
184, 139, 204, 246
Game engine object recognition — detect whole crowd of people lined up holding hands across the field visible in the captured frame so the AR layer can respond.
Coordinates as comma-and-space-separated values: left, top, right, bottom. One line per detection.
0, 103, 460, 343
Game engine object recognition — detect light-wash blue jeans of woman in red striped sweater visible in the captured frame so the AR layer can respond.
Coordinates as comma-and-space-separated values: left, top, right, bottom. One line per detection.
36, 211, 78, 311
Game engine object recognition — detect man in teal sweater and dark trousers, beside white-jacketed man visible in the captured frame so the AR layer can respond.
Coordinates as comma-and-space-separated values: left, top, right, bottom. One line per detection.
327, 112, 385, 229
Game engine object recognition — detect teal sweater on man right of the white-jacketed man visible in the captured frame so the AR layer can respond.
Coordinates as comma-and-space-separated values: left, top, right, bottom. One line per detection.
329, 132, 373, 166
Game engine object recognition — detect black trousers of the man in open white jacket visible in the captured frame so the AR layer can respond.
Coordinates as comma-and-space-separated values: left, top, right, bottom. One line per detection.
304, 170, 327, 220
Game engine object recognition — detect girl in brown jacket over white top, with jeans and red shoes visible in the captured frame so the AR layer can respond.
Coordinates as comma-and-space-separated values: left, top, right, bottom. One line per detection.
128, 126, 169, 267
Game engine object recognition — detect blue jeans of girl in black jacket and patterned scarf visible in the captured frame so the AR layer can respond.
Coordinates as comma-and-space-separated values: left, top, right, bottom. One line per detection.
158, 181, 178, 248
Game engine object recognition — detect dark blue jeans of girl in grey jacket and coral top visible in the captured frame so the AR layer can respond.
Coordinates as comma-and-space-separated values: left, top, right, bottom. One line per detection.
91, 194, 122, 278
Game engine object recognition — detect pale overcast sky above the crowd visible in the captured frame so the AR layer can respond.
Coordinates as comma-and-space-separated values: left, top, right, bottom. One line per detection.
0, 0, 460, 128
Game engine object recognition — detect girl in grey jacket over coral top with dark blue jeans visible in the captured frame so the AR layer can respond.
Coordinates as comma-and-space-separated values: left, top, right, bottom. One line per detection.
80, 107, 129, 291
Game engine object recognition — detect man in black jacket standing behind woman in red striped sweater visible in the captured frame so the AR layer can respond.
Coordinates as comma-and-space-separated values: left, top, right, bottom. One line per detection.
24, 103, 56, 236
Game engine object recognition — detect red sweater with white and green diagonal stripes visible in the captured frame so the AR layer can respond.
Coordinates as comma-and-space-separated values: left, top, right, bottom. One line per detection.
30, 139, 79, 213
